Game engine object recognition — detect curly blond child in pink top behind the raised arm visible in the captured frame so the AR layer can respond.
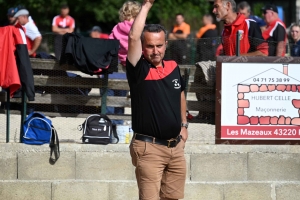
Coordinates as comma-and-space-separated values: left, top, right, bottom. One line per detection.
109, 1, 141, 71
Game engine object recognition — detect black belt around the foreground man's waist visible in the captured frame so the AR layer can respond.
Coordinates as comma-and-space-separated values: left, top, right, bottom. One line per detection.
134, 133, 181, 148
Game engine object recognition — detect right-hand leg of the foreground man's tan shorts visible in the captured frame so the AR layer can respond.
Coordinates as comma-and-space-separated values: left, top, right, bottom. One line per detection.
160, 140, 186, 200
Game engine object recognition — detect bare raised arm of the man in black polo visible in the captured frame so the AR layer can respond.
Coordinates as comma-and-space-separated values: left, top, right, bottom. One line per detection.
127, 0, 155, 66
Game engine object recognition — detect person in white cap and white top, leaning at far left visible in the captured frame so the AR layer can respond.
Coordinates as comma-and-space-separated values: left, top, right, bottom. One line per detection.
14, 9, 42, 57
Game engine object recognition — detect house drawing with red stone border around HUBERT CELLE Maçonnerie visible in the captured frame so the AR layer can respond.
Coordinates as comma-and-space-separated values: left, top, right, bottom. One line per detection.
235, 64, 300, 125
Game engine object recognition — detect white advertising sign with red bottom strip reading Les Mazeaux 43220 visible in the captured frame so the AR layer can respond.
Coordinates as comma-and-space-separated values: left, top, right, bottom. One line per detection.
218, 57, 300, 145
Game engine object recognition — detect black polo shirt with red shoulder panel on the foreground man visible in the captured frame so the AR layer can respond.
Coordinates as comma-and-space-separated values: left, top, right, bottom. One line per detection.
126, 56, 185, 139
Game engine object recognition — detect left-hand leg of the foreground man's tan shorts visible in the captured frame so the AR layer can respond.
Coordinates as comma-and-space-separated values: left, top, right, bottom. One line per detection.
130, 139, 171, 200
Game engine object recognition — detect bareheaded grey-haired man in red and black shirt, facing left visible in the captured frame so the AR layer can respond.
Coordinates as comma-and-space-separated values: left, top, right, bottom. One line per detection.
213, 0, 268, 56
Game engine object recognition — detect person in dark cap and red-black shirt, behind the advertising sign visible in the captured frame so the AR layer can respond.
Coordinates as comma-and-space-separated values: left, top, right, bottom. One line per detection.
262, 4, 287, 56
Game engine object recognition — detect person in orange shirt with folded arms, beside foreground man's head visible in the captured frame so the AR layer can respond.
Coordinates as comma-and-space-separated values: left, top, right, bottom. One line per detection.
168, 13, 191, 64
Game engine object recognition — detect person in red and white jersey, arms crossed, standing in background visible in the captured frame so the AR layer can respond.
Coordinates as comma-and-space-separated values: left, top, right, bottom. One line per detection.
52, 4, 75, 59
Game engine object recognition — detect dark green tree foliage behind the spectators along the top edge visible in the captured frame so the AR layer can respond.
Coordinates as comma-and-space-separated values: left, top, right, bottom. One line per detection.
0, 0, 211, 32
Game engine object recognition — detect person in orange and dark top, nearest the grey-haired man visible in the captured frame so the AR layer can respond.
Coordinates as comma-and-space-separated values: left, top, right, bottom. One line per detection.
196, 14, 219, 61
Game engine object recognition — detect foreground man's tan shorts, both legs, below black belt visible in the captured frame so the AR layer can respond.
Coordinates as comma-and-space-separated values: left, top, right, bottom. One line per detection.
129, 138, 186, 200
